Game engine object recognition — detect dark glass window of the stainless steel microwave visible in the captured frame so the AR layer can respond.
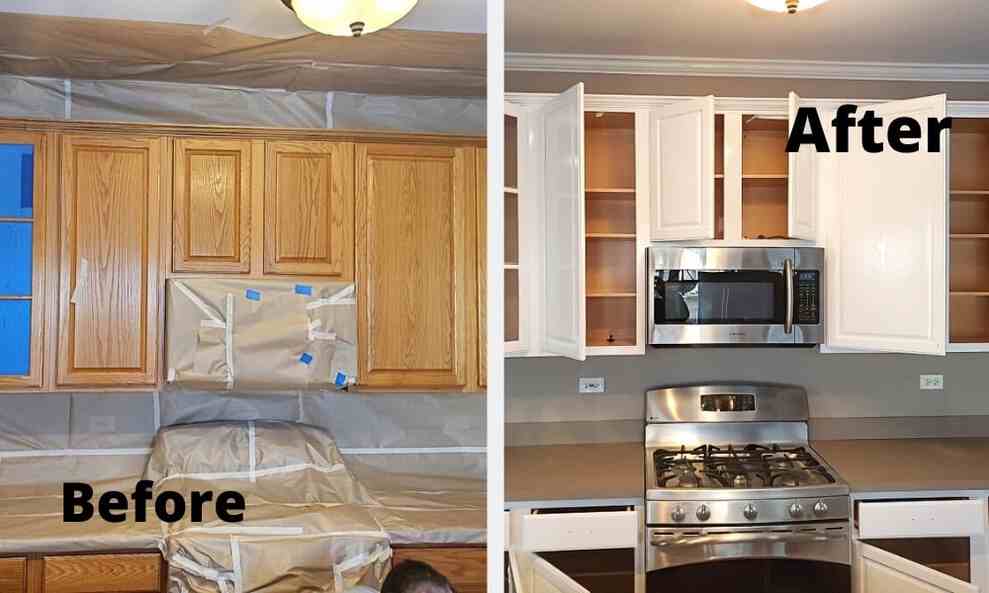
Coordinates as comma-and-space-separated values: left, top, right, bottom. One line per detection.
653, 270, 786, 325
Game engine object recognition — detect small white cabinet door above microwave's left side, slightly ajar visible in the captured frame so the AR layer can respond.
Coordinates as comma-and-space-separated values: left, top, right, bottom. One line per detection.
650, 96, 715, 241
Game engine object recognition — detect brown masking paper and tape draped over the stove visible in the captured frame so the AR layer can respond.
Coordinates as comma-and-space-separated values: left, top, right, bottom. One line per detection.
144, 421, 391, 593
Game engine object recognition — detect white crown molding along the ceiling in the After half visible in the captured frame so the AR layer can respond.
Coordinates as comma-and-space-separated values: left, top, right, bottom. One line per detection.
505, 52, 989, 82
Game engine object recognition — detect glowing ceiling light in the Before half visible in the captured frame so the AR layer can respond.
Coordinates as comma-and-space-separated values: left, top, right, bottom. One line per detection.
282, 0, 419, 37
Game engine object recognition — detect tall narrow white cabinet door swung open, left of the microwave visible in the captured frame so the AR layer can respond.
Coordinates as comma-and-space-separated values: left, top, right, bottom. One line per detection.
534, 83, 587, 360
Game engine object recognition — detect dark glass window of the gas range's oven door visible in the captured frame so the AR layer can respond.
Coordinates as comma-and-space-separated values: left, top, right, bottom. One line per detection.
646, 558, 852, 593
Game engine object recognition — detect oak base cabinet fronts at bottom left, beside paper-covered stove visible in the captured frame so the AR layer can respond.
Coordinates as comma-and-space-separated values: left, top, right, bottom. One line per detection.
0, 553, 165, 593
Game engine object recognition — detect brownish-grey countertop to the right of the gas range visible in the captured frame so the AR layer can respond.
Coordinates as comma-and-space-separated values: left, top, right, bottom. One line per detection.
811, 438, 989, 493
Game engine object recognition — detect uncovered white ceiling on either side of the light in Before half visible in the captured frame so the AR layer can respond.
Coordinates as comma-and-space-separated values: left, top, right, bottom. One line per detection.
0, 0, 485, 38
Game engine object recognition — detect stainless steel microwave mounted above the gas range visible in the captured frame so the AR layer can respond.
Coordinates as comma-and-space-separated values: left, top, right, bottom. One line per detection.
649, 246, 827, 346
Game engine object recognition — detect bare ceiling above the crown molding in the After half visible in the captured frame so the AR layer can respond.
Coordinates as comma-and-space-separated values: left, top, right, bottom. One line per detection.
505, 0, 989, 64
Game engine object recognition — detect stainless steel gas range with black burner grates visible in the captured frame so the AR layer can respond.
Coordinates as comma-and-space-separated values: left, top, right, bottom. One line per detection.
645, 384, 851, 593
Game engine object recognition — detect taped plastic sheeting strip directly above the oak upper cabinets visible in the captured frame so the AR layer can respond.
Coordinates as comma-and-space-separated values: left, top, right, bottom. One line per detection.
0, 75, 485, 134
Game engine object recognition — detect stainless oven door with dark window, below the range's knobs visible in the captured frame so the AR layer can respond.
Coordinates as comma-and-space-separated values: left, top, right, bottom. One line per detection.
646, 522, 852, 593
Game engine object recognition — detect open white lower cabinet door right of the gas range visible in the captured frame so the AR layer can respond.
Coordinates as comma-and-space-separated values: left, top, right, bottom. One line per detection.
854, 542, 979, 593
